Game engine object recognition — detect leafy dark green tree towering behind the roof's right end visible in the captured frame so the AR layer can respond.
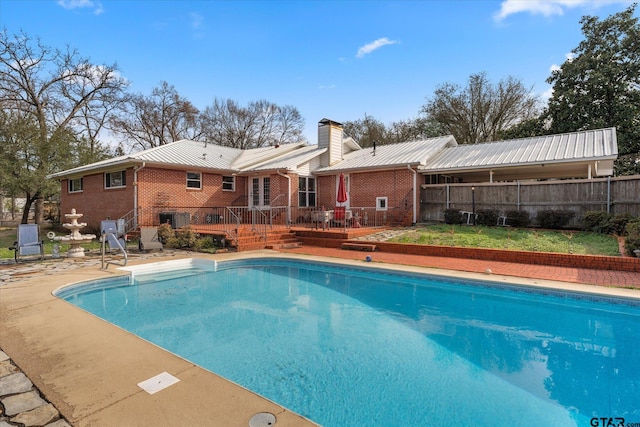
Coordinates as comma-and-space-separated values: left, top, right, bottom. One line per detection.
547, 4, 640, 175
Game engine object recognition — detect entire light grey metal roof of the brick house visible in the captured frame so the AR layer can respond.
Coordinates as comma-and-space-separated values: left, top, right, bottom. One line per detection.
48, 128, 618, 178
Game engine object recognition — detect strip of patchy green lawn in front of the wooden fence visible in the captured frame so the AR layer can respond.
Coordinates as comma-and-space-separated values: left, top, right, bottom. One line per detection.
389, 225, 620, 256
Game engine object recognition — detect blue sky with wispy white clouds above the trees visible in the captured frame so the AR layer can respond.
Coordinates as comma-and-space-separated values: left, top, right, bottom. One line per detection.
0, 0, 637, 143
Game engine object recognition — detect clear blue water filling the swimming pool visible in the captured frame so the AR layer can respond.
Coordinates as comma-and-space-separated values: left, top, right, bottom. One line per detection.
58, 258, 640, 427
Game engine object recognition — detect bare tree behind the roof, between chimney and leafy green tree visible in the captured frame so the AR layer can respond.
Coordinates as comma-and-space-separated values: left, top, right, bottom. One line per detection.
422, 73, 540, 144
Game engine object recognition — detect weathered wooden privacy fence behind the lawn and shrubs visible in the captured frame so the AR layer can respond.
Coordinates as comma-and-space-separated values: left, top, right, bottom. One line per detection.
420, 175, 640, 226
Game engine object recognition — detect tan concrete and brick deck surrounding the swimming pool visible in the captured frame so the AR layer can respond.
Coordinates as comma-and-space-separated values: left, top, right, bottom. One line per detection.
0, 247, 640, 426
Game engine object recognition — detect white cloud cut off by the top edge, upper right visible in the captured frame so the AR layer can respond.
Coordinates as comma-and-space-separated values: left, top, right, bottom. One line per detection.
493, 0, 632, 21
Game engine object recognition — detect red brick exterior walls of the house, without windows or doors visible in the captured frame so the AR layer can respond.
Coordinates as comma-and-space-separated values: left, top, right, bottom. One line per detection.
61, 167, 415, 229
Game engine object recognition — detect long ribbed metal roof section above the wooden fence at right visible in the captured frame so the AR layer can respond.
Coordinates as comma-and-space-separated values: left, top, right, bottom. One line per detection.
420, 128, 618, 172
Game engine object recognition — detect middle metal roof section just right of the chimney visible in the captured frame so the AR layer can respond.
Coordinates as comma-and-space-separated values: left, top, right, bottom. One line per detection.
315, 135, 457, 174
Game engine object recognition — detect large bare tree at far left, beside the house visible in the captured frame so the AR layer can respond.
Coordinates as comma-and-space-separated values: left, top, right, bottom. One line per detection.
0, 30, 127, 222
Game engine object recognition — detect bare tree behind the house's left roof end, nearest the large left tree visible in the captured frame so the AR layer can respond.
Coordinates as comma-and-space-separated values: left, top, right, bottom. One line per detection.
110, 81, 200, 150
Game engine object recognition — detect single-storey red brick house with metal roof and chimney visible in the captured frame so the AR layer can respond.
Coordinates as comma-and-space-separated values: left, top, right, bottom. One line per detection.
49, 119, 617, 236
